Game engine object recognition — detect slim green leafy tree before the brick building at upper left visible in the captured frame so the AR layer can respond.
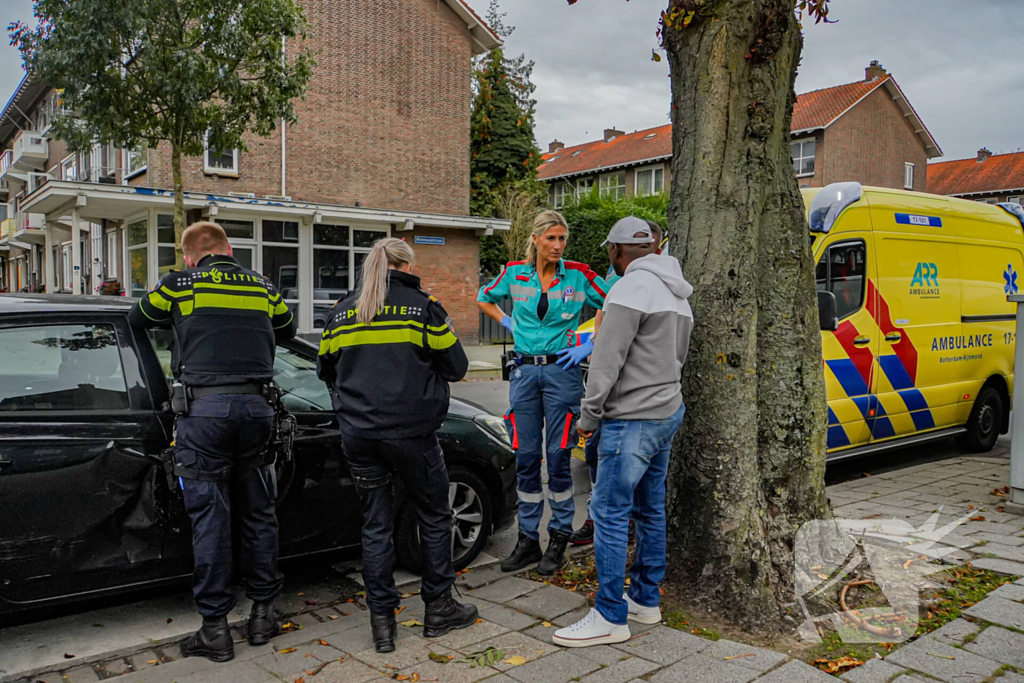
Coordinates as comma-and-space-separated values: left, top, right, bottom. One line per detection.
8, 0, 314, 263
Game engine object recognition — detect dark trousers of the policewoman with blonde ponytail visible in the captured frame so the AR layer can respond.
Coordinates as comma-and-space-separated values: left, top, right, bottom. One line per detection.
342, 432, 455, 614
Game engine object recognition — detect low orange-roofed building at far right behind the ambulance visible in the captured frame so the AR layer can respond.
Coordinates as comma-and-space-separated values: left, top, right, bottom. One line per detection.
928, 147, 1024, 204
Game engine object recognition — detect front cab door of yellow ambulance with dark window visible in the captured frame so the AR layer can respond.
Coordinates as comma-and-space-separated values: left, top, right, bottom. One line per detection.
816, 237, 884, 452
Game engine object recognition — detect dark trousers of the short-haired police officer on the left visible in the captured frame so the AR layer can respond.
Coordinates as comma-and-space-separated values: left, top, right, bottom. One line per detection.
174, 394, 284, 618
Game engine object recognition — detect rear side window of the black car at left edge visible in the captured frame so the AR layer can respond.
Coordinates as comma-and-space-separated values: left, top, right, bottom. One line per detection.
0, 325, 129, 411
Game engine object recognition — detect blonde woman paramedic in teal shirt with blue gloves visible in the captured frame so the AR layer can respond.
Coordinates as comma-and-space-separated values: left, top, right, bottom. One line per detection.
477, 211, 605, 574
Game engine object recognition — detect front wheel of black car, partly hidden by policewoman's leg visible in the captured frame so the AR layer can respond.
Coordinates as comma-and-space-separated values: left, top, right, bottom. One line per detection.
394, 467, 494, 573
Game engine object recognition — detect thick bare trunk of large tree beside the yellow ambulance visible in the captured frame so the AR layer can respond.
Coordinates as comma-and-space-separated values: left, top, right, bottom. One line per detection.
665, 0, 830, 631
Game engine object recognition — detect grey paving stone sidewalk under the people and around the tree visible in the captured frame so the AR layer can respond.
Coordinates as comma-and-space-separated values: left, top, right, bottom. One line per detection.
9, 457, 1024, 683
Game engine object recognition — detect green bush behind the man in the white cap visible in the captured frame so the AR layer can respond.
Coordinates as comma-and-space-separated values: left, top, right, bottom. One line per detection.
561, 187, 669, 275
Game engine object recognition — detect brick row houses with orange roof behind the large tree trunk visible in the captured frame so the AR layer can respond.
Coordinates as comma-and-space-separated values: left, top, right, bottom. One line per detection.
540, 61, 942, 207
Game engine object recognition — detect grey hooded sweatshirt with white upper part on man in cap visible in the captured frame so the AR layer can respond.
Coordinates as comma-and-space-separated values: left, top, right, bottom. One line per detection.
580, 254, 693, 431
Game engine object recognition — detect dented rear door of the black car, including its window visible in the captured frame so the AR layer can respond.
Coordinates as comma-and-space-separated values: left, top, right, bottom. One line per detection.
0, 313, 166, 603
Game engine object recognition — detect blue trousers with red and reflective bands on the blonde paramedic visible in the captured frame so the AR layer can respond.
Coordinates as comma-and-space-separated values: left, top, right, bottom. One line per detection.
505, 365, 583, 539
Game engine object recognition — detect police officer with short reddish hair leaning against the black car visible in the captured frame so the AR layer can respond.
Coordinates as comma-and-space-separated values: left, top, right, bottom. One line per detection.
129, 222, 295, 661
